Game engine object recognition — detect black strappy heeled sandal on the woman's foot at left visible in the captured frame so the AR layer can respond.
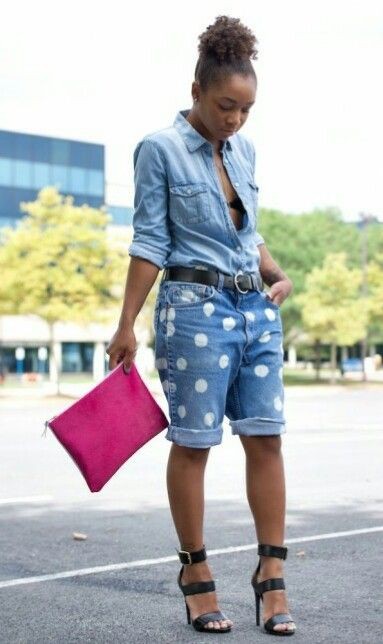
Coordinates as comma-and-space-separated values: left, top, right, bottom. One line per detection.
177, 546, 231, 633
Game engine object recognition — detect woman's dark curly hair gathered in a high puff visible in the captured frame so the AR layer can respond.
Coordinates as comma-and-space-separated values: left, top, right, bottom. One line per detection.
194, 16, 258, 91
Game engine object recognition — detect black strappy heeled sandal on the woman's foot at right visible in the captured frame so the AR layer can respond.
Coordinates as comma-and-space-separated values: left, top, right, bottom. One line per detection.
251, 543, 296, 635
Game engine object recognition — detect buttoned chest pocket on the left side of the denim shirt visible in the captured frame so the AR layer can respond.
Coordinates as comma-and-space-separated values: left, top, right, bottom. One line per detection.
169, 182, 210, 224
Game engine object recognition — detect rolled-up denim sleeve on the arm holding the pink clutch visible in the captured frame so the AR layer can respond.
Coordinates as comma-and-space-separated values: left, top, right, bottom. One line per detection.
128, 139, 171, 269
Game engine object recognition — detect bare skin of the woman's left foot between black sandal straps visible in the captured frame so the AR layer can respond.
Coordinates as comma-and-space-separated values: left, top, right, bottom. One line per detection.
181, 561, 233, 630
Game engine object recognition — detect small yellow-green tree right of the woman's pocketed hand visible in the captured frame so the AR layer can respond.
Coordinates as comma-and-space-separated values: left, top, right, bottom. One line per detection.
296, 253, 369, 382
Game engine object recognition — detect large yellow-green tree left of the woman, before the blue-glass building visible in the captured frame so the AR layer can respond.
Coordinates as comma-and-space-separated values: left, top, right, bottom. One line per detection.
0, 187, 128, 393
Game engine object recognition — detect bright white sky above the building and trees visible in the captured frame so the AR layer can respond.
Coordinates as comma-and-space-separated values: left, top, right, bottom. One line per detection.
0, 0, 383, 221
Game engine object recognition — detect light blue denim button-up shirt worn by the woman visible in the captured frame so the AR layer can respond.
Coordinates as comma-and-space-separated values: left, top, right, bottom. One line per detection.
129, 110, 265, 274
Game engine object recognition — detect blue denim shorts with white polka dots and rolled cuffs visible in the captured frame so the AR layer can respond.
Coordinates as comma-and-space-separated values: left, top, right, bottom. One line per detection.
153, 280, 286, 448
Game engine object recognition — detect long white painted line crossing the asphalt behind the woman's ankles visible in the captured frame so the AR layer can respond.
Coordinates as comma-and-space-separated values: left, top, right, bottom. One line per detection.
0, 526, 383, 588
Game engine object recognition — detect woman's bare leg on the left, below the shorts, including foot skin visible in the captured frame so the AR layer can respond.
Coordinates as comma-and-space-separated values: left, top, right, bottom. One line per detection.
167, 443, 232, 628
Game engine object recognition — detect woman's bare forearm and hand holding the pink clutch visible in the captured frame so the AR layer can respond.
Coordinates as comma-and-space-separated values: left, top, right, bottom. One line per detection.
106, 257, 160, 371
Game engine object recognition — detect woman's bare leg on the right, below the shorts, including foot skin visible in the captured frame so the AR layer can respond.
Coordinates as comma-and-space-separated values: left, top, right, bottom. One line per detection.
240, 435, 295, 630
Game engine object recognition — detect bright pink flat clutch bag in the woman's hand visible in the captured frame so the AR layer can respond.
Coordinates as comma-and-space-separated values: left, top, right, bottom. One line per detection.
44, 362, 169, 492
